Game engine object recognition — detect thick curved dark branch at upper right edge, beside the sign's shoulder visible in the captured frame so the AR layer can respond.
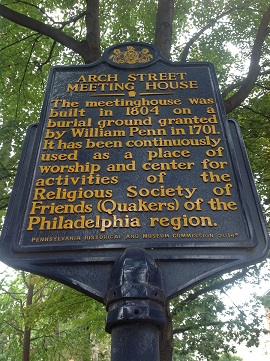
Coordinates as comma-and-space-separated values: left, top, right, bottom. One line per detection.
224, 6, 270, 113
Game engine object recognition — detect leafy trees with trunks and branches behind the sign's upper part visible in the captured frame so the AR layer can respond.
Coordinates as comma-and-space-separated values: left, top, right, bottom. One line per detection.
0, 0, 270, 219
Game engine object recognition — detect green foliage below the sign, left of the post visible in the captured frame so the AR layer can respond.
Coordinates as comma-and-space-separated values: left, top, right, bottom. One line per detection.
0, 273, 110, 361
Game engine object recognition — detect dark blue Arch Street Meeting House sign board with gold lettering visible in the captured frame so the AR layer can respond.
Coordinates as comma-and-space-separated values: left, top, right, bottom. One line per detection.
0, 43, 269, 356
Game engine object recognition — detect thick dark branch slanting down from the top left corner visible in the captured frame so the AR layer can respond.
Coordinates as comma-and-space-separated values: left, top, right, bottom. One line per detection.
0, 5, 87, 59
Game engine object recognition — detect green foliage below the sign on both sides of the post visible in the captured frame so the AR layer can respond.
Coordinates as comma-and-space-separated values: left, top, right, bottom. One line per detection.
0, 267, 269, 361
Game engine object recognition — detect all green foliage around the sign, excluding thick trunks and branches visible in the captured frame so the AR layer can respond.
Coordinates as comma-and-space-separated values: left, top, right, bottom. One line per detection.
0, 0, 270, 361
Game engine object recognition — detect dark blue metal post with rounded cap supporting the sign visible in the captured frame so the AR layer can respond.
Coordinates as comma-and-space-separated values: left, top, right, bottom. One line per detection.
105, 248, 166, 361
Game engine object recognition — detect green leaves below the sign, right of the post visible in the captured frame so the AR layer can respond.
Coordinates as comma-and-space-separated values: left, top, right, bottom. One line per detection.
170, 265, 269, 361
